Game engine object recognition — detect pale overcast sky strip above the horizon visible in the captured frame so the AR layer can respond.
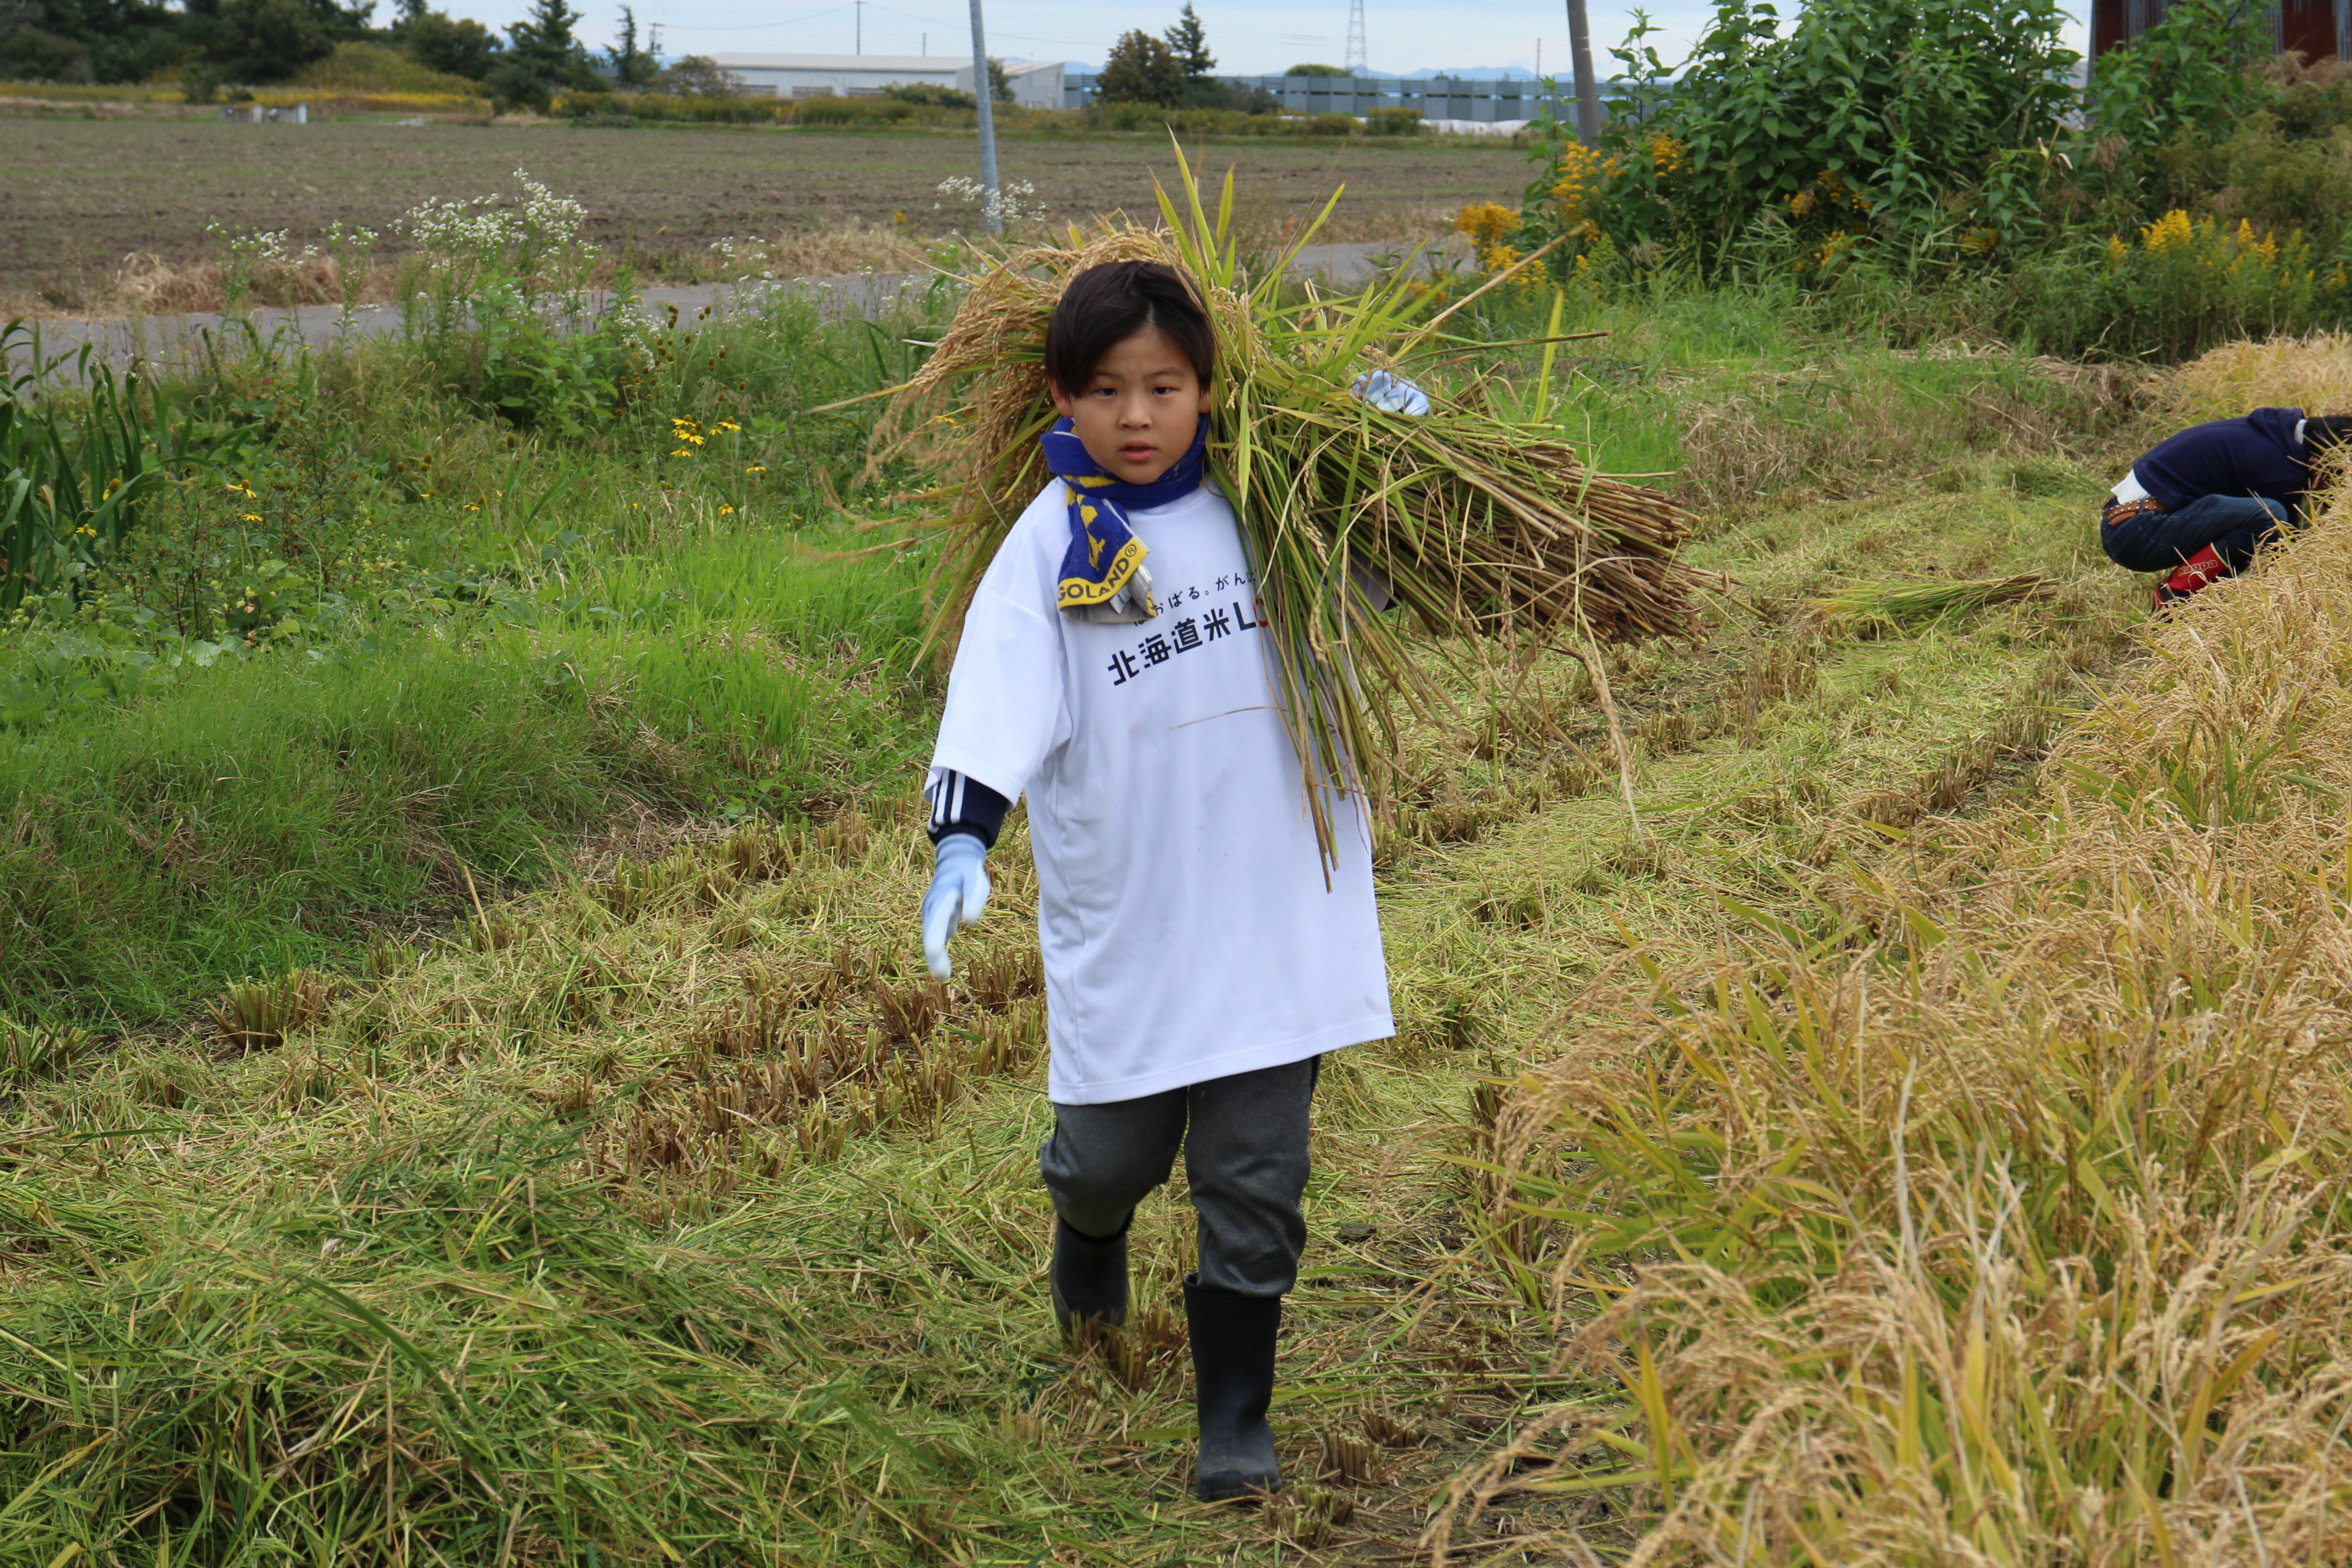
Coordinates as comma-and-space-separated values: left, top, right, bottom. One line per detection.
468, 0, 2084, 75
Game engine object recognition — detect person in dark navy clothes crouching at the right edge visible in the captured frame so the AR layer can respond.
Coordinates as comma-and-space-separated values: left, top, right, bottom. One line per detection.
2098, 409, 2352, 613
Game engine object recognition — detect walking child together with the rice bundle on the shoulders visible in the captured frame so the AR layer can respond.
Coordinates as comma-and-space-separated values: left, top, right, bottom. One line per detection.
893, 172, 1691, 1500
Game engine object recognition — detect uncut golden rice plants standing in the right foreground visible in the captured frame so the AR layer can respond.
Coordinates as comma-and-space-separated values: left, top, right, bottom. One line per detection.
1440, 480, 2352, 1563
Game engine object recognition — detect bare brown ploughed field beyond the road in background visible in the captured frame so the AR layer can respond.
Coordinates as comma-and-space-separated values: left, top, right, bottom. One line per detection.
0, 118, 1526, 310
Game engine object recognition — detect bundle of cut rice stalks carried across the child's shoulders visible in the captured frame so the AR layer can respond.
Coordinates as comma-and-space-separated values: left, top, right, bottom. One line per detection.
877, 150, 1696, 844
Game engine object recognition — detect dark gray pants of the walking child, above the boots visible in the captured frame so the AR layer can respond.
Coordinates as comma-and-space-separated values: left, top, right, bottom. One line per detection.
1037, 1055, 1322, 1295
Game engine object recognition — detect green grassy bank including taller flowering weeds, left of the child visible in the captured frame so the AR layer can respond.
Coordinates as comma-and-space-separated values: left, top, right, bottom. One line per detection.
0, 291, 936, 1027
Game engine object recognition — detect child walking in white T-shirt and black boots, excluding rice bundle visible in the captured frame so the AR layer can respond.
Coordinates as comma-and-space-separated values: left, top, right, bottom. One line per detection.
922, 261, 1392, 1500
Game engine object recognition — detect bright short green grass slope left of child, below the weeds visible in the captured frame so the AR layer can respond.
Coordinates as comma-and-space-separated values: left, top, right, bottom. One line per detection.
0, 571, 929, 1027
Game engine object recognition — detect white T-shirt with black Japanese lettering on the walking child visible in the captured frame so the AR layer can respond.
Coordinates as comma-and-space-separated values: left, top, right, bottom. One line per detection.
931, 480, 1395, 1105
